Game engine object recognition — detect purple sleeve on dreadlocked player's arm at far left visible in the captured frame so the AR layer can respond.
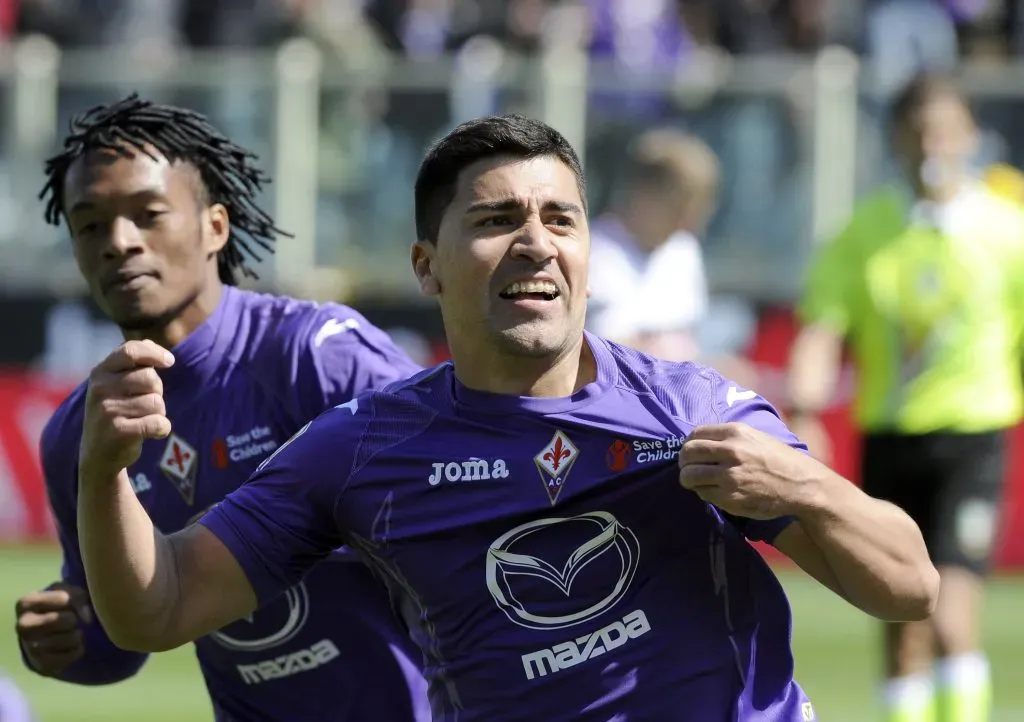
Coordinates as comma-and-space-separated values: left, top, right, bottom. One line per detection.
22, 411, 148, 685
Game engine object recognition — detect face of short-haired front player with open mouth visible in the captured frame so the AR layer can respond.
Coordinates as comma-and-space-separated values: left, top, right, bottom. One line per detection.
413, 156, 590, 357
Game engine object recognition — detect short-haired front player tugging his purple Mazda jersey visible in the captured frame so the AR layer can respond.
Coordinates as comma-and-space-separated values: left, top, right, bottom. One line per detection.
70, 116, 938, 722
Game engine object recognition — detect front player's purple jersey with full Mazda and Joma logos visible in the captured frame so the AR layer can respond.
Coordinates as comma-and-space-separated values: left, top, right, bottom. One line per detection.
202, 334, 814, 722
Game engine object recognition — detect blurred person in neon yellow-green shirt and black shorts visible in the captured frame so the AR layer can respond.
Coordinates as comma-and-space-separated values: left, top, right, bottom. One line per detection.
791, 76, 1024, 722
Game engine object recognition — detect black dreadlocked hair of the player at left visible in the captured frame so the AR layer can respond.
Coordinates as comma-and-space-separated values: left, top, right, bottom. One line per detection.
39, 93, 291, 286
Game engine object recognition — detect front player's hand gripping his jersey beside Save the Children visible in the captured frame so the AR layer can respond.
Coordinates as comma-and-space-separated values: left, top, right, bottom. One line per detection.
679, 423, 825, 519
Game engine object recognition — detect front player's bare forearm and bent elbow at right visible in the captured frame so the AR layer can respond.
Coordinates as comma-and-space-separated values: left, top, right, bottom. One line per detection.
798, 474, 939, 621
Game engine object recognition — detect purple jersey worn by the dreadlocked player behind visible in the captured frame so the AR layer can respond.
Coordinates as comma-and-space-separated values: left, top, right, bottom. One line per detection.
41, 288, 429, 722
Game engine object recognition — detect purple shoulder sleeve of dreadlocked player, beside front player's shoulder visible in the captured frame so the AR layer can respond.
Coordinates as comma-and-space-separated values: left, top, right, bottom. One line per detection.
291, 303, 421, 423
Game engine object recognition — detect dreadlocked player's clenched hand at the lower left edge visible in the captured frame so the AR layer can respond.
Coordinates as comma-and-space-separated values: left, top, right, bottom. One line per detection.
14, 582, 92, 677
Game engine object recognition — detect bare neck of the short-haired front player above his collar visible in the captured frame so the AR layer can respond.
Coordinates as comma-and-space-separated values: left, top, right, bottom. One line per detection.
452, 333, 597, 398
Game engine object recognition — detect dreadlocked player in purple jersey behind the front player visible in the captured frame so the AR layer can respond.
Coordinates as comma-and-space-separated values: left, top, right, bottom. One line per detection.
17, 95, 429, 722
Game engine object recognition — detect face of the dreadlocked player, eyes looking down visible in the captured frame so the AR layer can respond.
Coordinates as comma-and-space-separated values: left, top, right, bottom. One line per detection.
63, 151, 228, 330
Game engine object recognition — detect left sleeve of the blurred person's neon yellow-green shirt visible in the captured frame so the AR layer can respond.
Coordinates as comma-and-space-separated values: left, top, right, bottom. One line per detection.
797, 225, 859, 334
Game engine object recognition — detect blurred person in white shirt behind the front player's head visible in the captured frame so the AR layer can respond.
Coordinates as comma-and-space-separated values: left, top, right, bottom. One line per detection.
587, 125, 761, 383
